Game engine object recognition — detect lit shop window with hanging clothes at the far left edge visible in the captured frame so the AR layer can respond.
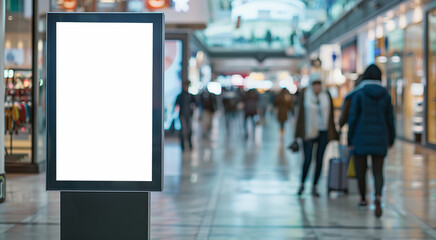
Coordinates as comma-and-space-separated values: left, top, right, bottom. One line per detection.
4, 0, 34, 163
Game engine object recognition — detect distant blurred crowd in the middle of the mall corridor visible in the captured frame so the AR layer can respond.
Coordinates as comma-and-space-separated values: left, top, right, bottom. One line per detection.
175, 79, 297, 146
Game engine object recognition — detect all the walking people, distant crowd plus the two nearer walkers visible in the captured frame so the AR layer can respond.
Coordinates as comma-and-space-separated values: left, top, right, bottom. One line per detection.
176, 64, 395, 217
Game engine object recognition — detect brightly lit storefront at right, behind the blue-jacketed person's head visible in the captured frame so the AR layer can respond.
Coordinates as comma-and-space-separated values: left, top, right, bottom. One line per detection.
358, 2, 428, 143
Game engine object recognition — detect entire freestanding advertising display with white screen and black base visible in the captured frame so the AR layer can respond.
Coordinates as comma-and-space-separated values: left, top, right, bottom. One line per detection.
47, 13, 165, 240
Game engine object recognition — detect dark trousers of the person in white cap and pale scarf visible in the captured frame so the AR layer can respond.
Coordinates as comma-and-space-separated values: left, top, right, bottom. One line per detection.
301, 131, 328, 186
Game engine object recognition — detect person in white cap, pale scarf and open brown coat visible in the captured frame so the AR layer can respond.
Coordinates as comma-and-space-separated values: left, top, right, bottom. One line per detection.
295, 73, 339, 197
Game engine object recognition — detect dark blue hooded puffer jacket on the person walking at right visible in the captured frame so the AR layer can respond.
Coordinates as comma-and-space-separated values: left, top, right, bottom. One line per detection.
347, 80, 395, 156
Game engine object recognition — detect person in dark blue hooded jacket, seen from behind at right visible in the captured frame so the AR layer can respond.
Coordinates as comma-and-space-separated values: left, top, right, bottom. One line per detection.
348, 64, 395, 217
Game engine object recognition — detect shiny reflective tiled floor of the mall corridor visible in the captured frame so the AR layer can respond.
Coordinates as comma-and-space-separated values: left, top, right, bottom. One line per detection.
0, 113, 436, 240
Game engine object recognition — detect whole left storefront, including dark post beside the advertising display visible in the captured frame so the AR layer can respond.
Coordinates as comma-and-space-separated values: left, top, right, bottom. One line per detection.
3, 0, 49, 172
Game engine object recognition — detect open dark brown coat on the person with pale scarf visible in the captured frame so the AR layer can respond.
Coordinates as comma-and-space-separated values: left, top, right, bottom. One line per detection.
295, 89, 339, 141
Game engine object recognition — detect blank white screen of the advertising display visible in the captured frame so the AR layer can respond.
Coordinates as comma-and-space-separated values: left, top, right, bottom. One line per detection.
56, 22, 153, 181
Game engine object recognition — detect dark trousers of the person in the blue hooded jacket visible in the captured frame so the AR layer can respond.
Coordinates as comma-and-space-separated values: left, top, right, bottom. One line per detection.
355, 156, 384, 199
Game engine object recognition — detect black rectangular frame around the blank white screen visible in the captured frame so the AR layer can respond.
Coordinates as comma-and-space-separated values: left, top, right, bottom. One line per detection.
46, 13, 165, 192
